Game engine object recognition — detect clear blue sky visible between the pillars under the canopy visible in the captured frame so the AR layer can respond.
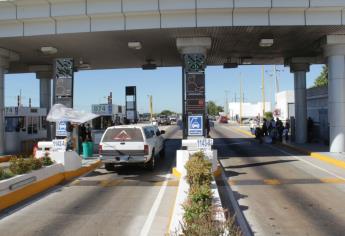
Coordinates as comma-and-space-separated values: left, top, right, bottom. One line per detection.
5, 65, 322, 112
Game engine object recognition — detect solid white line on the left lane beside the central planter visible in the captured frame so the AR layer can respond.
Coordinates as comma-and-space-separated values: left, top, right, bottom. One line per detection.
140, 174, 171, 236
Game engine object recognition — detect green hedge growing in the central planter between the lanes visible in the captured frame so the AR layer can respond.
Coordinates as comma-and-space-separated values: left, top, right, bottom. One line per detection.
182, 152, 241, 236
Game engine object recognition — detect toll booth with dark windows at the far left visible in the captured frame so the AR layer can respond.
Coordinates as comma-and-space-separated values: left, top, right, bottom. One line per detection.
5, 107, 49, 154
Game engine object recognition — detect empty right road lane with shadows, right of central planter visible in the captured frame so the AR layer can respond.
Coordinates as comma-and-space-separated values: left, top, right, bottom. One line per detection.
211, 124, 345, 236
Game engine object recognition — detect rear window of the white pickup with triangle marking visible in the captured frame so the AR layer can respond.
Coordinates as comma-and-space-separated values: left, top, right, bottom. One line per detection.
102, 128, 144, 142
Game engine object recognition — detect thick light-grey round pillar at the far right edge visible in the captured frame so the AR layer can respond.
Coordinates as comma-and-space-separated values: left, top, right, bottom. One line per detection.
324, 35, 345, 152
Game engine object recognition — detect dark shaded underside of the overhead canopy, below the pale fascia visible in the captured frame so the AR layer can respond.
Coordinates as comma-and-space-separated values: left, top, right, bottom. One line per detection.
0, 26, 345, 72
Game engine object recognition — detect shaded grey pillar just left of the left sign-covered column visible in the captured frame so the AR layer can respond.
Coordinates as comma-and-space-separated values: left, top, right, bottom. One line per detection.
36, 71, 52, 140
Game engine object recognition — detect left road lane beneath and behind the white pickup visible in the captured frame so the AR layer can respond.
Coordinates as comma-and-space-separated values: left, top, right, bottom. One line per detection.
0, 126, 182, 236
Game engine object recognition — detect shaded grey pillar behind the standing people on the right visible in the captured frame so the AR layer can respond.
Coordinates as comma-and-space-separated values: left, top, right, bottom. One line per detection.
290, 63, 309, 143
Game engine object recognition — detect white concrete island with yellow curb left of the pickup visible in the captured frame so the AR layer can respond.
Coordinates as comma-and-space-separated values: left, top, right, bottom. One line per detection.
0, 152, 100, 211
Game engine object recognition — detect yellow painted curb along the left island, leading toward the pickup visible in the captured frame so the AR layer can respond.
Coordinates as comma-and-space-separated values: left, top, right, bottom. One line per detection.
0, 161, 101, 211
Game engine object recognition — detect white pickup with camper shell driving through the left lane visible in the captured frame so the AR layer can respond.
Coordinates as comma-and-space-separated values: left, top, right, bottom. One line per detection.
99, 124, 165, 171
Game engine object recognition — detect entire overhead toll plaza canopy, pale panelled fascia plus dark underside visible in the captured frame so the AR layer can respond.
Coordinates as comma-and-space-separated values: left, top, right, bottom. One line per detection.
0, 0, 345, 72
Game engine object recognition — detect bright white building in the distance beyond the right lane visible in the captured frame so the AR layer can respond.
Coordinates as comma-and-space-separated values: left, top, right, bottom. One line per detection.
228, 102, 271, 120
